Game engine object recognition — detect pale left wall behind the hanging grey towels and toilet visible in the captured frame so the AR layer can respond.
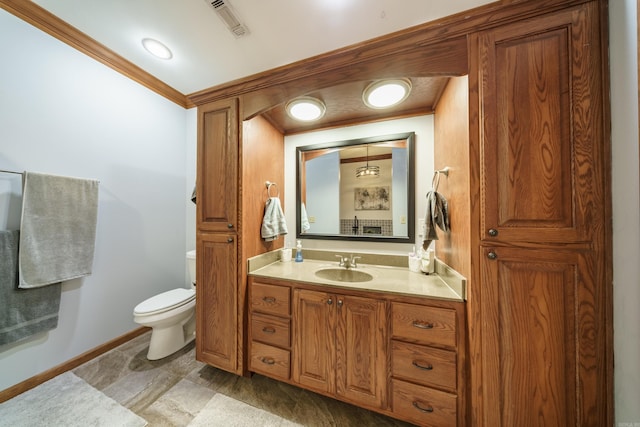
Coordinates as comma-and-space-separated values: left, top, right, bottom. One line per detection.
0, 10, 196, 390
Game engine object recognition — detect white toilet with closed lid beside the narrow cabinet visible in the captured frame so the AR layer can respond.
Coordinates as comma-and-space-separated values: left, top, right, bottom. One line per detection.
133, 251, 196, 360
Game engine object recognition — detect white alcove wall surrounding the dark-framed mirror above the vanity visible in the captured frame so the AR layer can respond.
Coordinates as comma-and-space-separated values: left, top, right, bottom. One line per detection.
284, 115, 433, 254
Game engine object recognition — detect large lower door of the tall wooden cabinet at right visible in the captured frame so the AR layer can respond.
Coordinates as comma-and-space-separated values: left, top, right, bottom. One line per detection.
479, 247, 607, 427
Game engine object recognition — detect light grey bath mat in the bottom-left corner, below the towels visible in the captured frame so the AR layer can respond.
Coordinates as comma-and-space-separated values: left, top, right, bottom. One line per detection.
0, 372, 147, 427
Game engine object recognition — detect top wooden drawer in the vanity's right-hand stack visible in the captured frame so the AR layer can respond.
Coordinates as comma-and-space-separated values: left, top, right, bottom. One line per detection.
391, 302, 456, 349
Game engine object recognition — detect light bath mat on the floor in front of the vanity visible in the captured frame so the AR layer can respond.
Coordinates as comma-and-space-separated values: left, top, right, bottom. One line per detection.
189, 393, 301, 427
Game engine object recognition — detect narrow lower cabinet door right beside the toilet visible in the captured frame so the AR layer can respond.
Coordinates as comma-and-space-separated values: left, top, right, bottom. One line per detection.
196, 233, 238, 372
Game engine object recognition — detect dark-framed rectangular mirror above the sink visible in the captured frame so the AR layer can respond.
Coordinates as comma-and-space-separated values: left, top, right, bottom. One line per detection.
296, 132, 415, 243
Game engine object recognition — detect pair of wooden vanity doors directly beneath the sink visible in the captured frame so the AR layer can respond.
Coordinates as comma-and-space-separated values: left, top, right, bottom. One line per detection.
293, 289, 387, 408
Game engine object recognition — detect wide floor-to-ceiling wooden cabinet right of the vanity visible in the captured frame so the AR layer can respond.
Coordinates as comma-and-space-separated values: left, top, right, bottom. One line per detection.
462, 2, 611, 427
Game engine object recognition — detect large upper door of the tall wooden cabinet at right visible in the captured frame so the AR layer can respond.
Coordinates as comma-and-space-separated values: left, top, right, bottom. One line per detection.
477, 4, 605, 242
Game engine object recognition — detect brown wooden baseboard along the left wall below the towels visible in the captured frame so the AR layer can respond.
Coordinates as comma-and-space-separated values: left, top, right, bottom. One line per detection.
0, 326, 151, 403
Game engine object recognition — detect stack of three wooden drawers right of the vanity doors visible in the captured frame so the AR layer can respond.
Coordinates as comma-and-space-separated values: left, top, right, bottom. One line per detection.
390, 301, 466, 427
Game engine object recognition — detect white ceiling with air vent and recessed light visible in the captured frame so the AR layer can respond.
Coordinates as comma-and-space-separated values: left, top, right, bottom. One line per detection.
33, 0, 492, 95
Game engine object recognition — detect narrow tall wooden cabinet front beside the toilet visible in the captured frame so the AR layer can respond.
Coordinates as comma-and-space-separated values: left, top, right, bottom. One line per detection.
196, 99, 239, 372
